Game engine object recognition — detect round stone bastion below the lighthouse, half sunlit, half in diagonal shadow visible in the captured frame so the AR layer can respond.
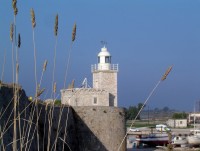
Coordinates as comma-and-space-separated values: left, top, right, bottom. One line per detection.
73, 106, 126, 151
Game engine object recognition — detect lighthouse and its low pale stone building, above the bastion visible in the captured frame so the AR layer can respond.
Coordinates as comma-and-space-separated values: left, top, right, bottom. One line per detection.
61, 46, 118, 107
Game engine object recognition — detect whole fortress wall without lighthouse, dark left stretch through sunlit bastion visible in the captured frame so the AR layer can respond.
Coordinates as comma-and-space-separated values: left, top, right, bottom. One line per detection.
0, 86, 126, 151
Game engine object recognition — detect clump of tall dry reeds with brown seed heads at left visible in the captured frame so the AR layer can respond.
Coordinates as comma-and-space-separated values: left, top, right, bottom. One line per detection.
0, 0, 79, 151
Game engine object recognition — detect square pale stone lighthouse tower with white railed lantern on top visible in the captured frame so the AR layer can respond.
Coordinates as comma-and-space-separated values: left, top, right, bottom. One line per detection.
91, 46, 118, 106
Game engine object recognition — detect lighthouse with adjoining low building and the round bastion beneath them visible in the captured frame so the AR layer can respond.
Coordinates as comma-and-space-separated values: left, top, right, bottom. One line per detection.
61, 46, 126, 151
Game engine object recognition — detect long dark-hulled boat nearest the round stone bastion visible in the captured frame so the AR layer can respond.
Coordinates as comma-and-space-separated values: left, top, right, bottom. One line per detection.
135, 133, 169, 147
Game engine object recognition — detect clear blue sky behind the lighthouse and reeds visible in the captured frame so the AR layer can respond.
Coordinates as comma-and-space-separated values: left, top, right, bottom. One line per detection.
0, 0, 200, 111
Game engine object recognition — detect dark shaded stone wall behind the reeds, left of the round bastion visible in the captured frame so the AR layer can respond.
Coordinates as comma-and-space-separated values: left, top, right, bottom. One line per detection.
0, 85, 79, 151
